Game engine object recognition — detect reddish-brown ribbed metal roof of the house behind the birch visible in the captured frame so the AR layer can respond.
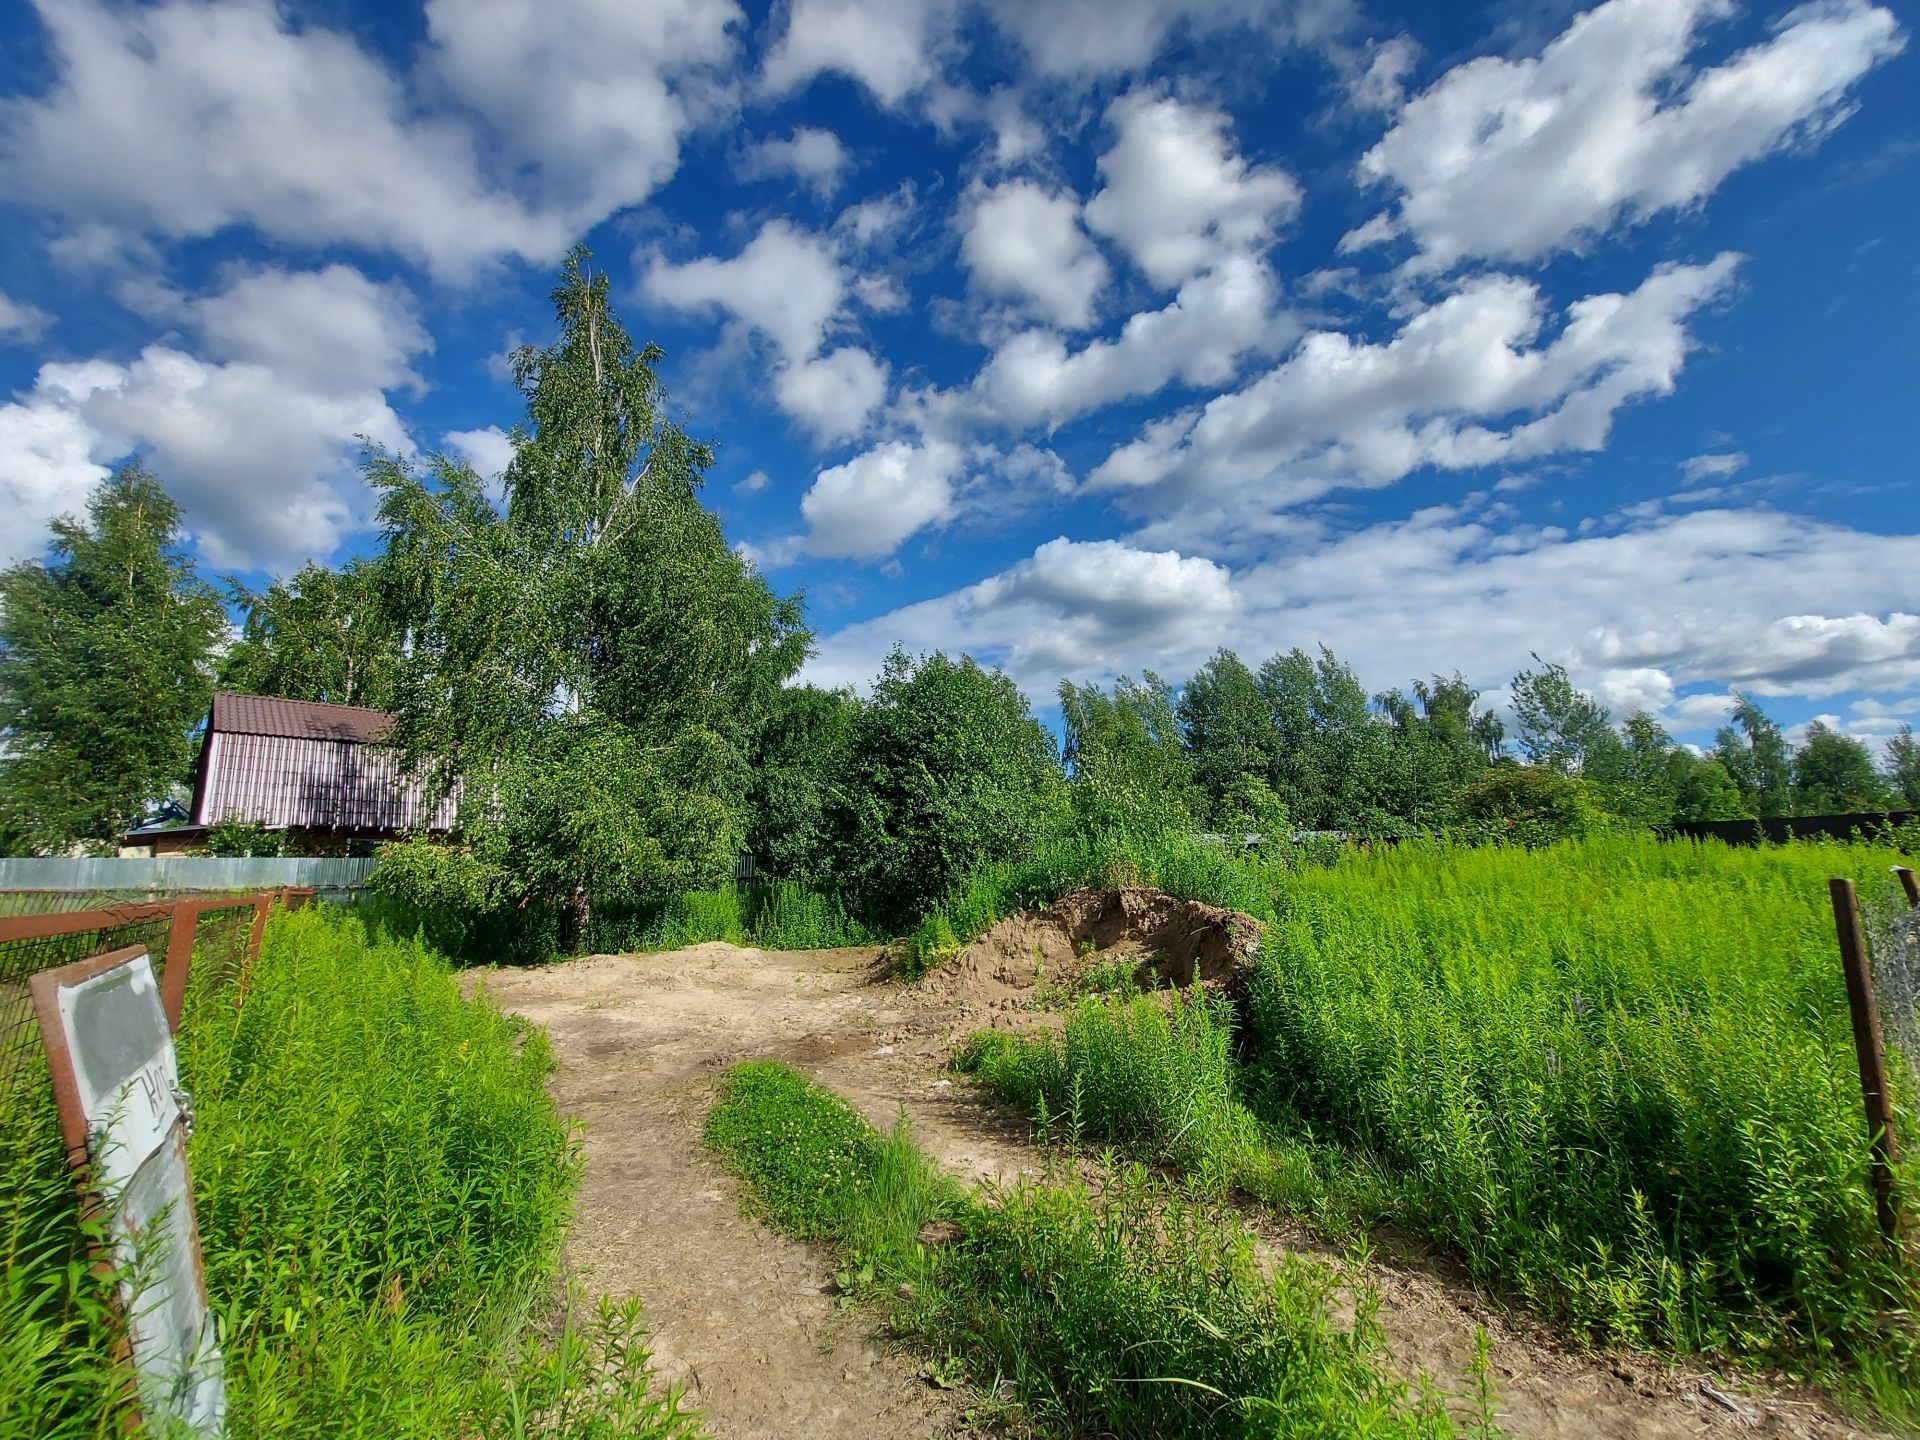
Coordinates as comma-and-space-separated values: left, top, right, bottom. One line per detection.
194, 691, 459, 833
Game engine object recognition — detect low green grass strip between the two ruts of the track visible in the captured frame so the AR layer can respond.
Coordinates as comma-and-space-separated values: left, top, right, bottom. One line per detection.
707, 1062, 1453, 1440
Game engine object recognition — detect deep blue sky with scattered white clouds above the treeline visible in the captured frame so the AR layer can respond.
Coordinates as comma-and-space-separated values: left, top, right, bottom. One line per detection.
0, 0, 1920, 741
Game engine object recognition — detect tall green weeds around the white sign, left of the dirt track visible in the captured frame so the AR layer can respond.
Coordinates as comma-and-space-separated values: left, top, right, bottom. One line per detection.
0, 906, 695, 1440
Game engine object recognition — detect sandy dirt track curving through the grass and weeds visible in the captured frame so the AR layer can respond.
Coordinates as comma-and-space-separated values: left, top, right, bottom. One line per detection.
482, 945, 1889, 1440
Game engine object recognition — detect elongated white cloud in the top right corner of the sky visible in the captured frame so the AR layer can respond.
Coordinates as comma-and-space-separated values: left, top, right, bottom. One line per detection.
1348, 0, 1905, 271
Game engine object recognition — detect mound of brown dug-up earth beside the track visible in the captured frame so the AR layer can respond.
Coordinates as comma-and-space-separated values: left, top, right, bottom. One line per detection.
925, 889, 1260, 1010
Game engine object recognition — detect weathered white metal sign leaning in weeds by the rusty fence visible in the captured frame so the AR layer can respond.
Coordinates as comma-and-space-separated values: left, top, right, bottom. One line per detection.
33, 947, 227, 1436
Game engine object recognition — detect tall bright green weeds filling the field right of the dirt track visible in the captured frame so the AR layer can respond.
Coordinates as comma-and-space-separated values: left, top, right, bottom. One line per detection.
975, 837, 1920, 1413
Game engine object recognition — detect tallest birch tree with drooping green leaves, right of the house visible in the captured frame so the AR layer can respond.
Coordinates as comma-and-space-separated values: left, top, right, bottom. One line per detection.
365, 250, 810, 947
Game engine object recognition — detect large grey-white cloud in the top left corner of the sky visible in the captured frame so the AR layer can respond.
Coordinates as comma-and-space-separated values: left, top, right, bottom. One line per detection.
0, 0, 570, 275
